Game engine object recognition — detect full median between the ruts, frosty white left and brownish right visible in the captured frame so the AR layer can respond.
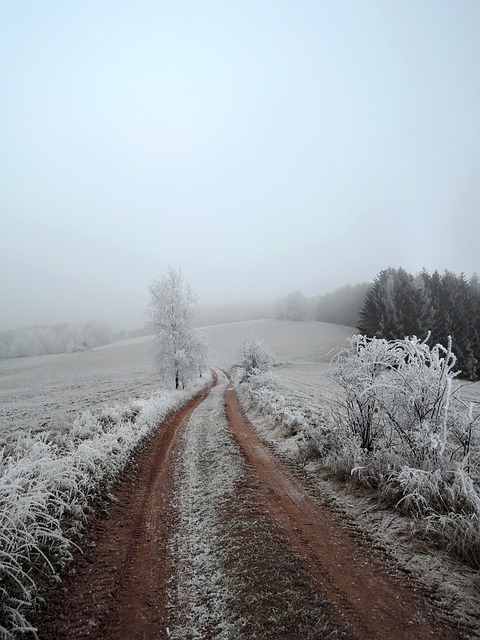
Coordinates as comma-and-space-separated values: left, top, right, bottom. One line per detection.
168, 378, 348, 640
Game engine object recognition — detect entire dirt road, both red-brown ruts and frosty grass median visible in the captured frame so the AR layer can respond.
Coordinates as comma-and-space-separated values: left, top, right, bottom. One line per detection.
33, 372, 461, 640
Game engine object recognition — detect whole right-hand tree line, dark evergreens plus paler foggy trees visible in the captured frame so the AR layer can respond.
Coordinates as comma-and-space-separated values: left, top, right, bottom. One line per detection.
275, 267, 480, 380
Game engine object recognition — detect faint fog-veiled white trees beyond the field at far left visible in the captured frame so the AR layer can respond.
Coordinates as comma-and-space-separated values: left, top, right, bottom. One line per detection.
0, 321, 114, 359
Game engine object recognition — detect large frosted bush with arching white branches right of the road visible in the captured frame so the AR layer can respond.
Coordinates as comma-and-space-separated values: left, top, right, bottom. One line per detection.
332, 335, 464, 468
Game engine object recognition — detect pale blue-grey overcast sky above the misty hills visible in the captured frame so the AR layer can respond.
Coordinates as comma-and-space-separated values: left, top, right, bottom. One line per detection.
0, 0, 480, 330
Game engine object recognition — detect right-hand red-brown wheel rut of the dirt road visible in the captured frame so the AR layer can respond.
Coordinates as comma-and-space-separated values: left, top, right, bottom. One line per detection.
225, 380, 459, 640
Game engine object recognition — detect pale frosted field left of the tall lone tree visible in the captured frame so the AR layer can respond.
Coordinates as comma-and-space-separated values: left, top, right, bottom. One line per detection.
0, 337, 159, 445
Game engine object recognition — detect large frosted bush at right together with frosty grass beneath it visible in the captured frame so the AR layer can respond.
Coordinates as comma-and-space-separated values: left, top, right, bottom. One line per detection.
324, 335, 480, 564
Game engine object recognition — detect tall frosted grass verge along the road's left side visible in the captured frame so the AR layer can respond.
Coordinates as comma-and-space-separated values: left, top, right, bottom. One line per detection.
0, 380, 205, 639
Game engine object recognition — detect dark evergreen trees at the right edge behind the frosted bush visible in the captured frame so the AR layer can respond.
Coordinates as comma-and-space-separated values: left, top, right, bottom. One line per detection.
358, 268, 480, 380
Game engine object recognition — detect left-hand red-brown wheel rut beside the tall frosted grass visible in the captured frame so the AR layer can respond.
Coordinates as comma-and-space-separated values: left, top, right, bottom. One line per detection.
31, 374, 218, 640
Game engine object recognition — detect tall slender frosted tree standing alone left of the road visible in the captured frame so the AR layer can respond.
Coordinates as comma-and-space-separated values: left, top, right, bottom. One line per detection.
147, 267, 206, 389
